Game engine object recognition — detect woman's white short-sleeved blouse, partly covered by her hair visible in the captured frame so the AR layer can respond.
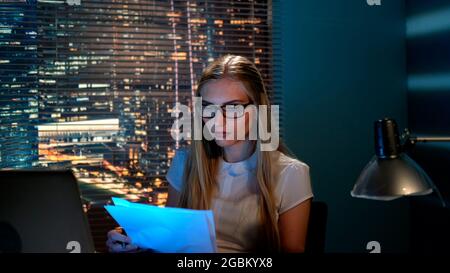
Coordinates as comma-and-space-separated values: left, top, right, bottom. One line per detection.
166, 149, 313, 252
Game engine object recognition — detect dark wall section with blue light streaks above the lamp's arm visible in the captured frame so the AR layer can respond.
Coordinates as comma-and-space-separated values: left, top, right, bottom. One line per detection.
406, 0, 450, 134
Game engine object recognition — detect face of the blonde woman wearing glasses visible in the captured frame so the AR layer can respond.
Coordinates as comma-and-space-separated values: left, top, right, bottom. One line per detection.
200, 78, 251, 147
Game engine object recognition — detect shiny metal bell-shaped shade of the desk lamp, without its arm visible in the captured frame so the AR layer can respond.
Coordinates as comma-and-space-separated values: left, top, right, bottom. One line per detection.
351, 154, 433, 201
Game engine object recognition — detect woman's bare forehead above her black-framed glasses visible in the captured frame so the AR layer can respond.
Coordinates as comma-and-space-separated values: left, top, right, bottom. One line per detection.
200, 78, 248, 104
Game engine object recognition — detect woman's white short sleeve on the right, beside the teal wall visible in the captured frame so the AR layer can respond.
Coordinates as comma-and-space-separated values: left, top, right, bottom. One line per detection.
278, 160, 314, 214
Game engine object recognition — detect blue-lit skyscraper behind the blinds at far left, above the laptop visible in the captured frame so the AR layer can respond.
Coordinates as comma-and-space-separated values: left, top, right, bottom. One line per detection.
0, 2, 39, 168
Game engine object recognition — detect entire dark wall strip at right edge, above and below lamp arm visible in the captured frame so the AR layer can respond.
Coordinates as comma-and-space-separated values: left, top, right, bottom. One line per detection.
406, 0, 450, 253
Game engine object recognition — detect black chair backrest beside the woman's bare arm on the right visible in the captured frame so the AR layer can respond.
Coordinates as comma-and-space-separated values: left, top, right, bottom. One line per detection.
305, 201, 328, 253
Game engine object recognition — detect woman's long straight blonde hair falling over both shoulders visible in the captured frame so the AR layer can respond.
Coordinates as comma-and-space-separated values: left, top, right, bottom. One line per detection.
178, 55, 291, 251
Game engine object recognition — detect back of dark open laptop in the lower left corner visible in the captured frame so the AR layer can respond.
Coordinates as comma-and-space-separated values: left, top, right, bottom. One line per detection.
0, 170, 94, 253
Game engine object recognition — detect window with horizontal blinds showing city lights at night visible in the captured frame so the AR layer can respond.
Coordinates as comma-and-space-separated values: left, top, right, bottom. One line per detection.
0, 0, 280, 251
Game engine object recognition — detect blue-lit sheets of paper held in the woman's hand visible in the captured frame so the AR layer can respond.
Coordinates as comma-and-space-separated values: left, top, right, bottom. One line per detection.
105, 197, 216, 253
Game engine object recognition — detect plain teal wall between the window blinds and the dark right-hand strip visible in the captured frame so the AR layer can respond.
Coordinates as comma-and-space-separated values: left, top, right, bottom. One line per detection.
280, 0, 409, 252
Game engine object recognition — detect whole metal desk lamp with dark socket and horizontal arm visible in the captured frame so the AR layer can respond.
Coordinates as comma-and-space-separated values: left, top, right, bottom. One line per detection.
350, 118, 450, 204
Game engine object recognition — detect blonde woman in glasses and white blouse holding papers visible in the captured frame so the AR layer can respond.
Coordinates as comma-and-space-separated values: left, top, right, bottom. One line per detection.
107, 55, 313, 252
